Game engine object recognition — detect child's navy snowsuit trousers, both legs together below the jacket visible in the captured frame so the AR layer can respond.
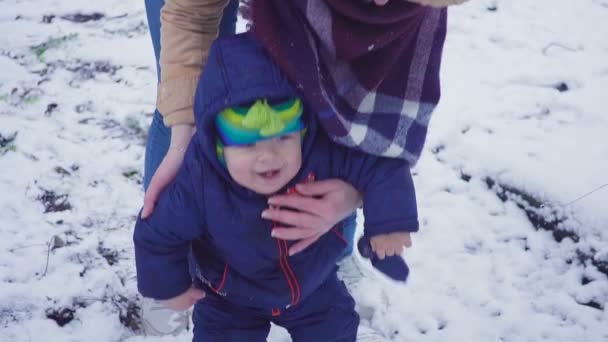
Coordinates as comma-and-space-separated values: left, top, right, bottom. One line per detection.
192, 273, 359, 342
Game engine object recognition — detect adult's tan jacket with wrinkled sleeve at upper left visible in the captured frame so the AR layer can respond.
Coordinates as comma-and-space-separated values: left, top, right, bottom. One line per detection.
156, 0, 466, 126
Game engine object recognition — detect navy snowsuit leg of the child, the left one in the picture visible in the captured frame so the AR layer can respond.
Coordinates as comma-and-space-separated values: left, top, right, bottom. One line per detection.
192, 292, 270, 342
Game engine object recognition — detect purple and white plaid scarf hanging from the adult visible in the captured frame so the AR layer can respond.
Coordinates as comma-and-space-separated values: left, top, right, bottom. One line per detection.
251, 0, 447, 165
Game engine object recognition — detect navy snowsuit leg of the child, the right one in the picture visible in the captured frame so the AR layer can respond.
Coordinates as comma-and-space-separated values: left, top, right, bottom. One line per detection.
274, 274, 359, 342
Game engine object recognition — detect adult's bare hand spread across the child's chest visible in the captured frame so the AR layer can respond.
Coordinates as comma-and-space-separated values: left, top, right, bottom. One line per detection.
262, 179, 361, 255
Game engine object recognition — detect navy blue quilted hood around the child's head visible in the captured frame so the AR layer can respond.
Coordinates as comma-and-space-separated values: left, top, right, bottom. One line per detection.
194, 33, 317, 188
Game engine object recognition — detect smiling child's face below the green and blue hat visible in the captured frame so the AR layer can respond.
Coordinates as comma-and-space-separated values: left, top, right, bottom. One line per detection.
224, 132, 302, 195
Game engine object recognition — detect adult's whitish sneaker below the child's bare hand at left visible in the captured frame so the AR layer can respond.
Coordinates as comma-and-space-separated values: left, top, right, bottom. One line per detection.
141, 297, 190, 336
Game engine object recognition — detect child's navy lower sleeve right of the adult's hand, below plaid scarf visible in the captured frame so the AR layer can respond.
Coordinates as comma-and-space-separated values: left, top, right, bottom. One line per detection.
343, 150, 418, 237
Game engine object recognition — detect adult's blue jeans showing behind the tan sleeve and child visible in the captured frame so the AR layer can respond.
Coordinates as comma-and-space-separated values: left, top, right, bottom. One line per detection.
144, 0, 356, 256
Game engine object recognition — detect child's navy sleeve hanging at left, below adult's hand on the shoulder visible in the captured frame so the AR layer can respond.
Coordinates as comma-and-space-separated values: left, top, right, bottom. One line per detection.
133, 145, 204, 299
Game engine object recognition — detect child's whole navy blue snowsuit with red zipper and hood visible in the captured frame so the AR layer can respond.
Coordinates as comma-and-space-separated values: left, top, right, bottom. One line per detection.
134, 34, 418, 342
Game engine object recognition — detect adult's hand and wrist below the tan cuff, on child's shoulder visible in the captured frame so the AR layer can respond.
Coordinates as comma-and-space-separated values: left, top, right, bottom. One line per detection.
141, 125, 196, 218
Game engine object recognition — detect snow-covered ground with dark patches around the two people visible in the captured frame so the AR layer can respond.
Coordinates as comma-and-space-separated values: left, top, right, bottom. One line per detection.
0, 0, 608, 342
